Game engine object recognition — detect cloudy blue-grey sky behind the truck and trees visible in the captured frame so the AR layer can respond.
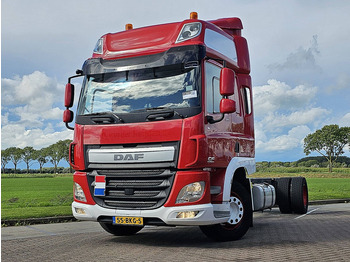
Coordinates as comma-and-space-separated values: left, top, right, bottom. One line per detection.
1, 0, 350, 170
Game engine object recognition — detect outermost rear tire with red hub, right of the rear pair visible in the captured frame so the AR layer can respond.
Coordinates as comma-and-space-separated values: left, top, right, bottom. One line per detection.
290, 177, 309, 214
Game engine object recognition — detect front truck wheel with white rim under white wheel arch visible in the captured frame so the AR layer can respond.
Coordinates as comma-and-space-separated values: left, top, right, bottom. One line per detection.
200, 183, 253, 241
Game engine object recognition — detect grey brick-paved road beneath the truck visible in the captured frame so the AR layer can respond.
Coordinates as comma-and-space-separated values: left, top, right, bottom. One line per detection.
1, 204, 350, 262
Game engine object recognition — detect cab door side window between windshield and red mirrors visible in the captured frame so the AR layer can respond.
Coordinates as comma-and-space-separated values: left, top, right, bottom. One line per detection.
205, 62, 221, 113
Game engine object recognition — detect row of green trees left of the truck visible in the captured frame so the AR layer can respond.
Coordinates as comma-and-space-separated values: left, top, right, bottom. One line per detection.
1, 139, 72, 173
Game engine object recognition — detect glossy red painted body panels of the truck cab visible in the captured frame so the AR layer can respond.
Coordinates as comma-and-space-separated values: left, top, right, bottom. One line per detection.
72, 15, 255, 209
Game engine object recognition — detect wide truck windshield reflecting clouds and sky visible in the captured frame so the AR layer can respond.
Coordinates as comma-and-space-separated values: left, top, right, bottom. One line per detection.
78, 64, 200, 115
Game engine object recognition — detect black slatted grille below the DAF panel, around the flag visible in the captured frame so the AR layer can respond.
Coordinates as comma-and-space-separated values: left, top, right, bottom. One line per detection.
88, 169, 175, 209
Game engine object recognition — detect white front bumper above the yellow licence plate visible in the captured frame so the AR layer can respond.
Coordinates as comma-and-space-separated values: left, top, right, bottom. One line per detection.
72, 202, 229, 226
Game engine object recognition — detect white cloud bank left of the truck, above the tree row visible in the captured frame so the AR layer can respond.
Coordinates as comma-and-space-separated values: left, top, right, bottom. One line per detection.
1, 71, 69, 148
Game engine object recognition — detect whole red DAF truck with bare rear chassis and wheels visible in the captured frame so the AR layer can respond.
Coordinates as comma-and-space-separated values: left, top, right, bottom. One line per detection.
63, 12, 308, 241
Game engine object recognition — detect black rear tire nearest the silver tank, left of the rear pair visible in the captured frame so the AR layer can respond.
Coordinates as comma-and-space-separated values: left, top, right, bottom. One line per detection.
276, 177, 292, 214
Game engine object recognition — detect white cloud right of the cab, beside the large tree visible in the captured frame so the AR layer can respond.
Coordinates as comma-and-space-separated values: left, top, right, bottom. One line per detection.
253, 79, 331, 155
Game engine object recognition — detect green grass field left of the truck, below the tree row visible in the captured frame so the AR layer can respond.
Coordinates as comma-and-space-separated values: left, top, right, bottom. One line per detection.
1, 175, 73, 220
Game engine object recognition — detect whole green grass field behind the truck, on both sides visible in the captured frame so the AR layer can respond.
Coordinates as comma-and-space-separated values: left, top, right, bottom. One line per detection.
1, 168, 350, 220
